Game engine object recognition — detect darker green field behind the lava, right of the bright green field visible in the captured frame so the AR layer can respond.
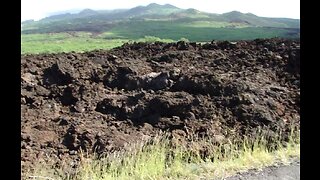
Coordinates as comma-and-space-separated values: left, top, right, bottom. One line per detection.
110, 21, 298, 41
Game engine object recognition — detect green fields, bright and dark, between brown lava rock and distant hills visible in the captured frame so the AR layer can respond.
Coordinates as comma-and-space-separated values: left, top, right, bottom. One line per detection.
21, 21, 299, 54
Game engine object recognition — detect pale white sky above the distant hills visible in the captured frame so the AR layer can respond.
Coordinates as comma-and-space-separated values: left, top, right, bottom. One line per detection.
21, 0, 300, 21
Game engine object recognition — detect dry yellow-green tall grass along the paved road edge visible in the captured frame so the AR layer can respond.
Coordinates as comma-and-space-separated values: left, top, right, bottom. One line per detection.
25, 125, 300, 180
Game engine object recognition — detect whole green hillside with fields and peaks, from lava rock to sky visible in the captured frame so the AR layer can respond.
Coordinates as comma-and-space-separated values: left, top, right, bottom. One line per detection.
21, 3, 300, 54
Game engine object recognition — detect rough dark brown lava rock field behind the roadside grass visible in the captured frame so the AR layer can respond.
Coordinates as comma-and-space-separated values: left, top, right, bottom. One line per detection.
21, 39, 300, 172
